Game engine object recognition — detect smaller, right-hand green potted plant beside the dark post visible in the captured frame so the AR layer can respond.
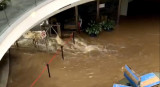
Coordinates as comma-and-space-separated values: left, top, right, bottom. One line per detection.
101, 20, 115, 31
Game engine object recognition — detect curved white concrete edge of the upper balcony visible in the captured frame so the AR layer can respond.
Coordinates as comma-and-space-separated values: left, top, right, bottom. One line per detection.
0, 0, 94, 60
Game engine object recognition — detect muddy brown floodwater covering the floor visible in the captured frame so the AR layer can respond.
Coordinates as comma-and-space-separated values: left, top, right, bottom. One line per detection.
7, 16, 160, 87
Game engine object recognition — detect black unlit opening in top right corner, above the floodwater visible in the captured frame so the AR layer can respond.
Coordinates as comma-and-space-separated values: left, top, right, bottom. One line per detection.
128, 0, 160, 16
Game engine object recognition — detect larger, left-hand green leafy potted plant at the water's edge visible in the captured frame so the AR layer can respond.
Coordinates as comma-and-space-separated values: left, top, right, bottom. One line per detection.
86, 21, 102, 37
